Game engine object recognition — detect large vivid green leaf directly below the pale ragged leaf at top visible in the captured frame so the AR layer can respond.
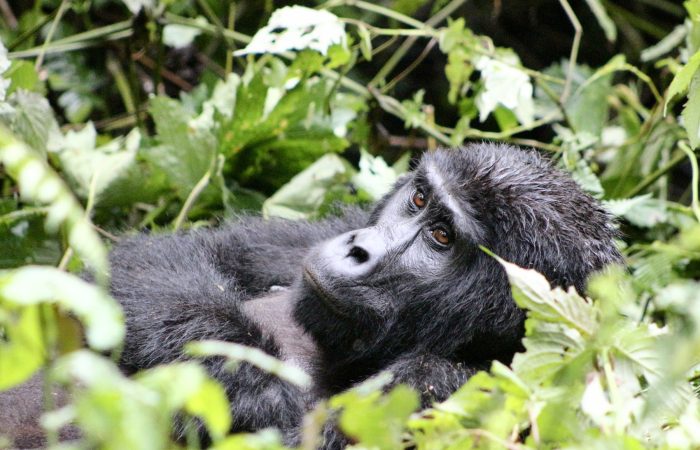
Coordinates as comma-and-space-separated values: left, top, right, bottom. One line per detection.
219, 74, 352, 192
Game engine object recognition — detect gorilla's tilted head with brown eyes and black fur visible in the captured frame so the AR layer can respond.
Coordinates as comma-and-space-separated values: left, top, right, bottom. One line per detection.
295, 144, 620, 386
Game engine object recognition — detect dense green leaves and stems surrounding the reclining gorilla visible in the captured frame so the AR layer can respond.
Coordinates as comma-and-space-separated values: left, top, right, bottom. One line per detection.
0, 0, 700, 449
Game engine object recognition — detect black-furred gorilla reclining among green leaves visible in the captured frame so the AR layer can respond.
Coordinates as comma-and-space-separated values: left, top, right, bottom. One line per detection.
0, 143, 621, 448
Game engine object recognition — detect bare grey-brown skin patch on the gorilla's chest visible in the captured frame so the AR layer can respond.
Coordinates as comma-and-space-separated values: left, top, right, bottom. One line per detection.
242, 291, 318, 373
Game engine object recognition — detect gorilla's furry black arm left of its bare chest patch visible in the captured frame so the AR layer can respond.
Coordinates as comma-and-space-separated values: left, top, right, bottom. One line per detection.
111, 225, 320, 440
